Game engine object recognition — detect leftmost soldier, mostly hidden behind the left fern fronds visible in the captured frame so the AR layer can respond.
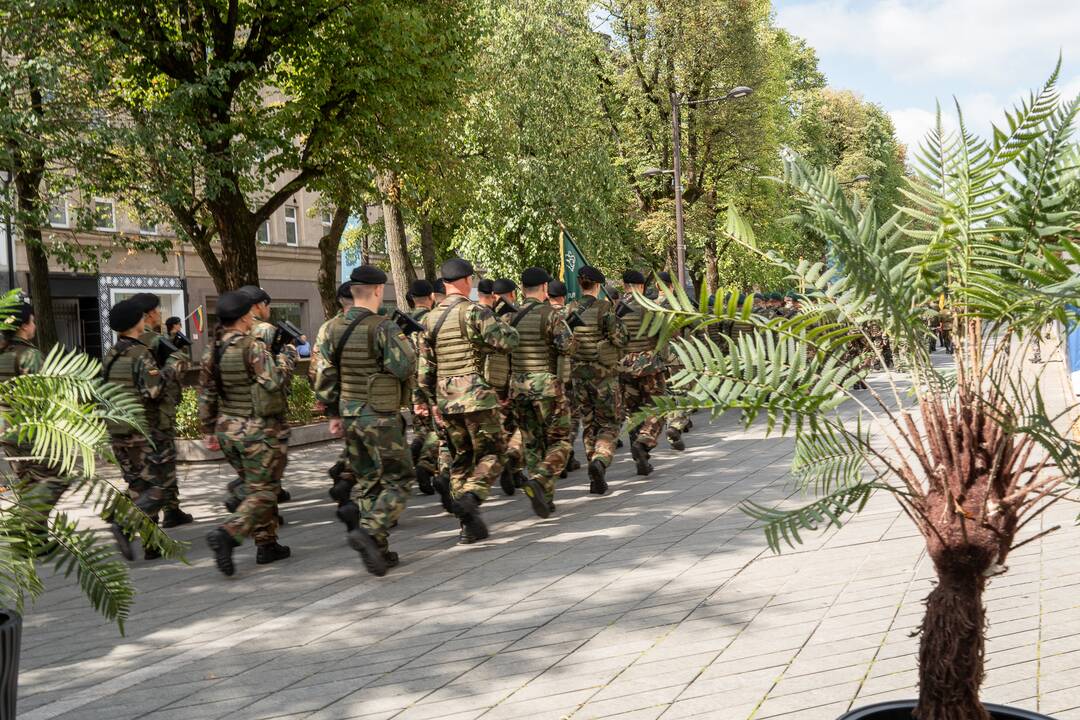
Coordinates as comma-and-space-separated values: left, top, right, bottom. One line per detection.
0, 300, 68, 535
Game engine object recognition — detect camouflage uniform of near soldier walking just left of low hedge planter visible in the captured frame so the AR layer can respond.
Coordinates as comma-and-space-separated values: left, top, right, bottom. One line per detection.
199, 330, 295, 545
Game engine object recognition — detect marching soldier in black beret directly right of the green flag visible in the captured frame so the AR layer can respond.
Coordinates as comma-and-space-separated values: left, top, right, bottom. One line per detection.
570, 266, 626, 495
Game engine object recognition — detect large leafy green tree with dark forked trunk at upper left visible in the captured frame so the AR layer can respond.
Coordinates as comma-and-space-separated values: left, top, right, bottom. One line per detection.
69, 0, 472, 291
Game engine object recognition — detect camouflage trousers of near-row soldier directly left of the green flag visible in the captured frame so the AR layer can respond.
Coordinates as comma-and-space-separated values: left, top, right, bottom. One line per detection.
510, 372, 573, 501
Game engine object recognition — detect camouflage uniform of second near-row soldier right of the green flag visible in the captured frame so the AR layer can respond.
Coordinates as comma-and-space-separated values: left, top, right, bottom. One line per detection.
619, 296, 667, 450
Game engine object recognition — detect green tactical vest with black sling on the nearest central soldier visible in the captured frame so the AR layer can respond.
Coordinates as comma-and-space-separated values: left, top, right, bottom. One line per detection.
329, 313, 408, 412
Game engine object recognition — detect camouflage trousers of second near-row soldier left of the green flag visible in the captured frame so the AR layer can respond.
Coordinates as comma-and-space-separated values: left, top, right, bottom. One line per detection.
443, 409, 507, 501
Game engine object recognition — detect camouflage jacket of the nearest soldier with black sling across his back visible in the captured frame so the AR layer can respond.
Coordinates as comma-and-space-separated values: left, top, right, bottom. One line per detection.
315, 308, 416, 418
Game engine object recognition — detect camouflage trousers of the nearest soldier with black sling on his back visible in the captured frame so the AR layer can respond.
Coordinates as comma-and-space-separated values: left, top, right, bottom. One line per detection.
342, 407, 416, 539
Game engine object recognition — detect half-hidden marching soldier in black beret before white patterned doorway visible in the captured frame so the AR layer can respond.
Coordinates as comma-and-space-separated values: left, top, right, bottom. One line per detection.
131, 293, 193, 528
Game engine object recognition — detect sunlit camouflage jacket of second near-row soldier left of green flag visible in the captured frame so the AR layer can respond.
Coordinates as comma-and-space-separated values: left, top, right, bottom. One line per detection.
419, 295, 517, 415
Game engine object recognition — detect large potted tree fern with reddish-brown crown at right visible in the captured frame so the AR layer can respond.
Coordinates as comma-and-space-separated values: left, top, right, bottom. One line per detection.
639, 71, 1080, 720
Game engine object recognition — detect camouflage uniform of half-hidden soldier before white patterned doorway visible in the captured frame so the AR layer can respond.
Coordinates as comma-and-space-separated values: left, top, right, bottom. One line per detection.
139, 330, 191, 510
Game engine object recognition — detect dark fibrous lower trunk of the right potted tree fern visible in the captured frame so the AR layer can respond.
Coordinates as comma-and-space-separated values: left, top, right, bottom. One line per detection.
915, 563, 990, 720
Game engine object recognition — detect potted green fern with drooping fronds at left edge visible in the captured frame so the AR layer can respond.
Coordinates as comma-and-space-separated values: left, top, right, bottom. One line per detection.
0, 294, 183, 720
